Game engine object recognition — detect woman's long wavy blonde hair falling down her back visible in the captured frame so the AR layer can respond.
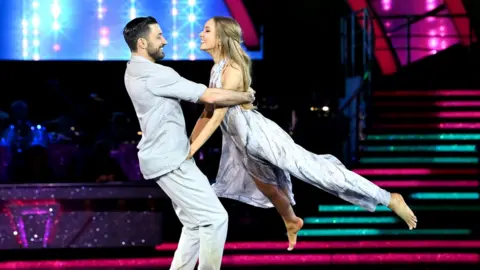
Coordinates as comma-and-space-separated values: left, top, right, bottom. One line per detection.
212, 16, 252, 91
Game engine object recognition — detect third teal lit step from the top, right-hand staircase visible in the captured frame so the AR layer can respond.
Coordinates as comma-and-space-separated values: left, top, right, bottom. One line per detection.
360, 157, 478, 164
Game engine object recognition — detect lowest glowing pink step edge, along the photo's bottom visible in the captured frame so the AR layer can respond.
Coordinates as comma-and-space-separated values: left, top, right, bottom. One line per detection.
0, 253, 480, 269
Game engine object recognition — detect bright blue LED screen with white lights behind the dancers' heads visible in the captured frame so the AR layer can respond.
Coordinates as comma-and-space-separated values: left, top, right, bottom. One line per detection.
0, 0, 263, 61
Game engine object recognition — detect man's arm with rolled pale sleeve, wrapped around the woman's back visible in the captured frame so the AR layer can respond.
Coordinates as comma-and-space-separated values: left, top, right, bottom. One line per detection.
147, 66, 255, 106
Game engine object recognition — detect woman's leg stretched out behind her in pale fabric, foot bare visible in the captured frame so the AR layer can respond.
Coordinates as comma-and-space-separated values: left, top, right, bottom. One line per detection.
249, 137, 417, 230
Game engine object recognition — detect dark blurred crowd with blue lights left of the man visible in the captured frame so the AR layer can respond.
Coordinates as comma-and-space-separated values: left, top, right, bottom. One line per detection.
0, 94, 141, 183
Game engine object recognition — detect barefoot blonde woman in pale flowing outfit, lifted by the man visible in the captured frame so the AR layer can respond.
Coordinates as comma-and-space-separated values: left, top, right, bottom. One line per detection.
190, 17, 417, 250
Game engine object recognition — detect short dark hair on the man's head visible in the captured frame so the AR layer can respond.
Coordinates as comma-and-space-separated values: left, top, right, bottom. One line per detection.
123, 16, 158, 52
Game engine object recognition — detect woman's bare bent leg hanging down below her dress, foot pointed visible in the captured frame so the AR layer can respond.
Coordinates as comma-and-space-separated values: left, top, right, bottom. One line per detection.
253, 178, 303, 250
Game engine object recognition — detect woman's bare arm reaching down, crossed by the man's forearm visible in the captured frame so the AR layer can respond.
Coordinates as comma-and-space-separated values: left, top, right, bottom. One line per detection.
189, 65, 242, 157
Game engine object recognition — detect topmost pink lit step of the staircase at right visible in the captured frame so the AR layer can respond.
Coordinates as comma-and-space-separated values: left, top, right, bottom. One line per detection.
373, 90, 480, 97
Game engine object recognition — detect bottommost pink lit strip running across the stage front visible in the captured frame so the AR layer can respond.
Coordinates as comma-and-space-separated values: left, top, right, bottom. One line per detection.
0, 253, 480, 270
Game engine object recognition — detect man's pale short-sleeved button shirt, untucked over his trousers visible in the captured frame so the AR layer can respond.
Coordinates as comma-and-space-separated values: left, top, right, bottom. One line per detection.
125, 56, 207, 179
